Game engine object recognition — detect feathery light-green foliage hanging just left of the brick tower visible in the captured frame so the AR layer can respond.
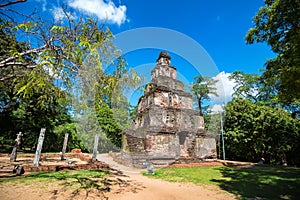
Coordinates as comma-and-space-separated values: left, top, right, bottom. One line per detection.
73, 53, 141, 152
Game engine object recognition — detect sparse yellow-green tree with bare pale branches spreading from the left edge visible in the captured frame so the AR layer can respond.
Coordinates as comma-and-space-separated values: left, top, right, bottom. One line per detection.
0, 1, 139, 152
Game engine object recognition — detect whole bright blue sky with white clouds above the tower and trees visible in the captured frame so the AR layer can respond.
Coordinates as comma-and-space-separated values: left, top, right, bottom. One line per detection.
10, 0, 274, 109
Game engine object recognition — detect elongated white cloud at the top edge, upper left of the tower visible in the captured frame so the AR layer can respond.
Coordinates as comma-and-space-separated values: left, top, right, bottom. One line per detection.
68, 0, 127, 25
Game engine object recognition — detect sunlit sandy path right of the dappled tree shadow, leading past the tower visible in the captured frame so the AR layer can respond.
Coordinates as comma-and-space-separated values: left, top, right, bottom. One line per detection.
98, 154, 236, 200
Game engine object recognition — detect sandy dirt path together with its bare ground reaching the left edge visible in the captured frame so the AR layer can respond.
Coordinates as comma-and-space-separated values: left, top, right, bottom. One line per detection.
0, 154, 236, 200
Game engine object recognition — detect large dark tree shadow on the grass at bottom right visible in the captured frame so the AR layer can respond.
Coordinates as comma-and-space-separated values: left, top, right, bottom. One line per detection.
211, 166, 300, 200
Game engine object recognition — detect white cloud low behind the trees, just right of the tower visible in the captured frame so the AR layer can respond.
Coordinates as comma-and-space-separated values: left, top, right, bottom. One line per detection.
210, 71, 236, 104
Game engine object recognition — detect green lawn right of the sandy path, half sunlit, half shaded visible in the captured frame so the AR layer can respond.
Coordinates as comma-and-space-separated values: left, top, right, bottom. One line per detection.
148, 166, 300, 200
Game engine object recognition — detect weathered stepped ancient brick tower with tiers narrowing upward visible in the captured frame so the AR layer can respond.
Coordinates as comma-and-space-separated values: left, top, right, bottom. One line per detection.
122, 52, 216, 165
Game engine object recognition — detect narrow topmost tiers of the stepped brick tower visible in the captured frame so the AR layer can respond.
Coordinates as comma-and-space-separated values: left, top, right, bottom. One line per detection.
151, 52, 177, 81
